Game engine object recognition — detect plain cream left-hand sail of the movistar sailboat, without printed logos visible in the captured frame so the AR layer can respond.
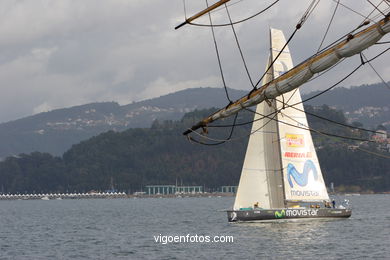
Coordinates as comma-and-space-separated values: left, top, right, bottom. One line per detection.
233, 54, 284, 210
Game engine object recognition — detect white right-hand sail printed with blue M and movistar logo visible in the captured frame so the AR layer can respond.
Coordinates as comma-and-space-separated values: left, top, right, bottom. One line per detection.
271, 29, 329, 202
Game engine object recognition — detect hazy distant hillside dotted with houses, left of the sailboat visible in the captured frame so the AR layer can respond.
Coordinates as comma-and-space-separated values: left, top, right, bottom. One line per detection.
0, 88, 245, 158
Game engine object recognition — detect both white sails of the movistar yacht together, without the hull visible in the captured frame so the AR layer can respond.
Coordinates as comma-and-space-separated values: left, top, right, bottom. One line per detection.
234, 29, 329, 210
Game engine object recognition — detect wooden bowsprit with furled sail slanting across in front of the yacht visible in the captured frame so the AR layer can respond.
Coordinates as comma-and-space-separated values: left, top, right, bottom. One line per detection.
183, 14, 390, 135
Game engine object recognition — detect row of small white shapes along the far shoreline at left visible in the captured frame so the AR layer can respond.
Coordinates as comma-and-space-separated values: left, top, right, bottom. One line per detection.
0, 192, 127, 200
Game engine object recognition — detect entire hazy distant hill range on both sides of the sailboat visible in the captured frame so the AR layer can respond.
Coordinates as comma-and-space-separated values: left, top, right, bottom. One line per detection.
0, 84, 390, 158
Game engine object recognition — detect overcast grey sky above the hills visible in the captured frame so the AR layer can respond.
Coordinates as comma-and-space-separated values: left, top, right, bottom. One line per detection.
0, 0, 390, 122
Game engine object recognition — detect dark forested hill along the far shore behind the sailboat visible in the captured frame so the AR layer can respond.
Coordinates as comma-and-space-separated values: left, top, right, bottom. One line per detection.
0, 106, 390, 193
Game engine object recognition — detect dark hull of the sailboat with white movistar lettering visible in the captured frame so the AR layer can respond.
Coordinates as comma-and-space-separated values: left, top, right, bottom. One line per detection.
227, 208, 352, 222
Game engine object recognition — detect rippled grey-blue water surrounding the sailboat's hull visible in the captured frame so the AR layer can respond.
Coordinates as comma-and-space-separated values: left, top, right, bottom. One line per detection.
0, 195, 390, 259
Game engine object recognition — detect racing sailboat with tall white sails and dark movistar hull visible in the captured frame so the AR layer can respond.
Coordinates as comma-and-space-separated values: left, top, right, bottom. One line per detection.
227, 29, 352, 222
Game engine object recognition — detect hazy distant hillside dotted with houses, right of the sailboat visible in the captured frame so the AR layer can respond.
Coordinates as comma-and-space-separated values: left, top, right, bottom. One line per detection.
303, 83, 390, 129
